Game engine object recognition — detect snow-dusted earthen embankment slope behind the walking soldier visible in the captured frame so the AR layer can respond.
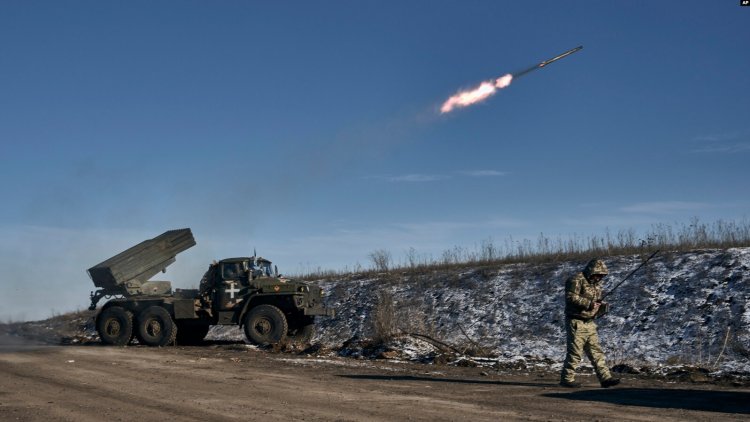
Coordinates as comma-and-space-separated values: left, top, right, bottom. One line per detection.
316, 248, 750, 373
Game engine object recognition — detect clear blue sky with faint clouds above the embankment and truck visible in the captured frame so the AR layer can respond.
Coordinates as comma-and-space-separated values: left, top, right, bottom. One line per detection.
0, 0, 750, 319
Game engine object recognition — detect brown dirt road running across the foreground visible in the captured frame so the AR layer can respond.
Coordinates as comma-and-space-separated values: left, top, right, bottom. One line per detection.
0, 343, 750, 421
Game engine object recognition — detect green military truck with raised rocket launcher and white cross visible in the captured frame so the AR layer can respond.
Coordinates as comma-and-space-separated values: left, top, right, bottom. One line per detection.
88, 229, 334, 346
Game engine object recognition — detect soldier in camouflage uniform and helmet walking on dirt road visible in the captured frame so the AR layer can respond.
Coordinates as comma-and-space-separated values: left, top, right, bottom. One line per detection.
560, 259, 620, 388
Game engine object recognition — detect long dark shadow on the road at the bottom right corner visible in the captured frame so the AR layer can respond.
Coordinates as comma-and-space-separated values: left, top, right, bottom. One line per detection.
542, 388, 750, 414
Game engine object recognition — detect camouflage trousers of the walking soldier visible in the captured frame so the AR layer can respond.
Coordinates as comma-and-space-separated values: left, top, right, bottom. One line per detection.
560, 318, 612, 382
